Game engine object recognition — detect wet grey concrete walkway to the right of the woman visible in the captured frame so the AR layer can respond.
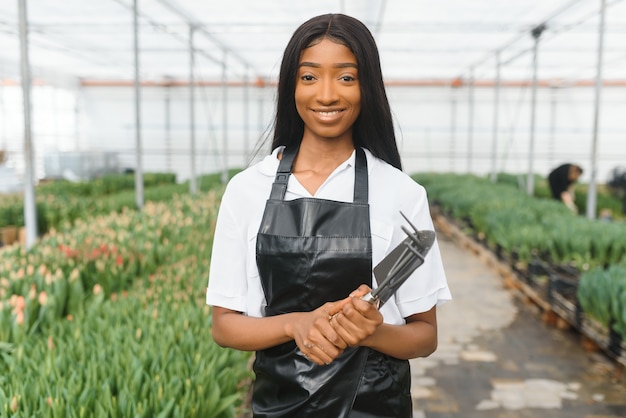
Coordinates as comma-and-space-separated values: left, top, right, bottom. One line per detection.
411, 233, 626, 418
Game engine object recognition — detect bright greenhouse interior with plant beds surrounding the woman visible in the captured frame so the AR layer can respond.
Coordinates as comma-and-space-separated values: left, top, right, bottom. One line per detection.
0, 0, 626, 418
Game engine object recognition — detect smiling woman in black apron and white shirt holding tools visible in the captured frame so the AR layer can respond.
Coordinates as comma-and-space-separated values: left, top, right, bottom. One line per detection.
207, 14, 450, 418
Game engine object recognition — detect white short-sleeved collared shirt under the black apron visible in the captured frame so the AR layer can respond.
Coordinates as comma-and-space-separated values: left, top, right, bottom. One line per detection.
206, 147, 451, 325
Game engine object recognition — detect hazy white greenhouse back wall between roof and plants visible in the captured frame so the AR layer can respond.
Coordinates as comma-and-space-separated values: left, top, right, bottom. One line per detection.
0, 85, 626, 182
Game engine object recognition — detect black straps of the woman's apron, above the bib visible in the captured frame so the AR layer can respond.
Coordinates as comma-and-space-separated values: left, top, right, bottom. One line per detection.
270, 146, 368, 203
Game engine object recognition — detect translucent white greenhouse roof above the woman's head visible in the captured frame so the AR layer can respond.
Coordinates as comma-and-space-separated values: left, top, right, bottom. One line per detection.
0, 0, 626, 83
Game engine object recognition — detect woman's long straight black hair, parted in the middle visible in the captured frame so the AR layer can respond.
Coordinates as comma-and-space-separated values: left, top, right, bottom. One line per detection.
272, 14, 402, 170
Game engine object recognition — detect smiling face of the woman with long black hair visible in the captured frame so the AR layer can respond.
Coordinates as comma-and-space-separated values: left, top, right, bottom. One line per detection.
295, 38, 361, 145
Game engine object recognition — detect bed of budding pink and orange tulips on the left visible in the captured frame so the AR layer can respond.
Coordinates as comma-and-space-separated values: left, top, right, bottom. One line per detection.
0, 192, 251, 417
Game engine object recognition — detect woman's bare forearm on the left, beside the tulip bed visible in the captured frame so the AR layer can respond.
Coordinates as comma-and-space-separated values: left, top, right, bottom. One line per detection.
212, 307, 302, 351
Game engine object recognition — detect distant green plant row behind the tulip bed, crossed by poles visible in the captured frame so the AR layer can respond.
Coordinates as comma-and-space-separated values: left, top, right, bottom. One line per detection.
0, 173, 236, 235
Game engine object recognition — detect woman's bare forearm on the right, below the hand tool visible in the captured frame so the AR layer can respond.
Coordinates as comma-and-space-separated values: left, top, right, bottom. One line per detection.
362, 321, 437, 359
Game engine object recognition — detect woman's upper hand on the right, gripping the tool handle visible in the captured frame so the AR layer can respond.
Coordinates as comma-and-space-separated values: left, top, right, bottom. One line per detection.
329, 285, 383, 347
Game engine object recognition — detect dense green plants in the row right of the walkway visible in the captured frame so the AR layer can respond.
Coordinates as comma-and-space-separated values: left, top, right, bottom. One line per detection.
413, 174, 626, 340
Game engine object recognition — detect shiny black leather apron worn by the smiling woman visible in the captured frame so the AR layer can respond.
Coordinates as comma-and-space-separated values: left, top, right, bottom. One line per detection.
252, 147, 412, 418
